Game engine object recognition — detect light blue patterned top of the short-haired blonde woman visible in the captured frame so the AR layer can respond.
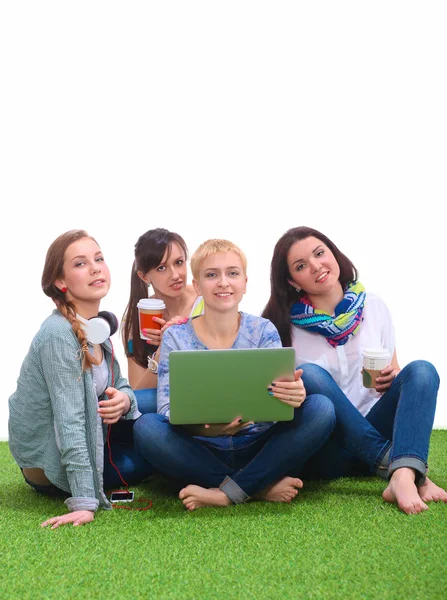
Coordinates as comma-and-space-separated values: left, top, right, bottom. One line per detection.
157, 312, 282, 445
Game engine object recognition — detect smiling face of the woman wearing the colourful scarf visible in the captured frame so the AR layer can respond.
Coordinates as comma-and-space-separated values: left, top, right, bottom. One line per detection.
287, 236, 341, 299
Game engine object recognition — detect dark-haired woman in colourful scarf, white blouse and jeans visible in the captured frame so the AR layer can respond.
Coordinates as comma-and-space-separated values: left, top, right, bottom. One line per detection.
262, 227, 447, 514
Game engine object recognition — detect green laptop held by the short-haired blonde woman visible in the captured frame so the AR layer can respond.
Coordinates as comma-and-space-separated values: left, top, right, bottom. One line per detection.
169, 348, 295, 425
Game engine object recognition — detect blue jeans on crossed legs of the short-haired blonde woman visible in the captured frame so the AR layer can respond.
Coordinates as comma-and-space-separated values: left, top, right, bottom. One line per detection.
134, 394, 335, 504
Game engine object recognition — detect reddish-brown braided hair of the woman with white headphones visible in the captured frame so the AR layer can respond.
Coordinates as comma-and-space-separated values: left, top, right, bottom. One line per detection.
42, 229, 97, 371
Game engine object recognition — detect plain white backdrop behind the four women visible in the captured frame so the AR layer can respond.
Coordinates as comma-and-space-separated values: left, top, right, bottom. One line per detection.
0, 0, 447, 439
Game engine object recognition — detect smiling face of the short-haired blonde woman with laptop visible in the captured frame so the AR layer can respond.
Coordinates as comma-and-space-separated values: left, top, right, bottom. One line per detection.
193, 252, 247, 312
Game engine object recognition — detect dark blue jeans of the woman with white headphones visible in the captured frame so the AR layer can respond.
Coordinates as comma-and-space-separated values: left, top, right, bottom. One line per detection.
24, 420, 154, 498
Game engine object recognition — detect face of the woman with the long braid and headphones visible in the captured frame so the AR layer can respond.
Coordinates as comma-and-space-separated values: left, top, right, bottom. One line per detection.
55, 237, 110, 312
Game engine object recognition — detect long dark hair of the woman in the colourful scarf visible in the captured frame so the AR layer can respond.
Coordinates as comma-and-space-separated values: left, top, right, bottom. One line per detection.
262, 226, 358, 346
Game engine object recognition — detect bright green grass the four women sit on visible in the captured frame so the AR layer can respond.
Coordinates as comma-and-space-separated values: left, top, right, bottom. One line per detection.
0, 431, 447, 600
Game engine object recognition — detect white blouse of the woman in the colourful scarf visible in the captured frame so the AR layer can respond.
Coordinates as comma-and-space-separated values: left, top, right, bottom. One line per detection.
292, 294, 395, 415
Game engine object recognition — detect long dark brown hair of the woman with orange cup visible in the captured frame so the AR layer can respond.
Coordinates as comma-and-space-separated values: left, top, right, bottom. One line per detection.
122, 228, 188, 369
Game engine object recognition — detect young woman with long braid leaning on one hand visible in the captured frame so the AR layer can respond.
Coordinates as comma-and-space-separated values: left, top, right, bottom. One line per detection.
9, 230, 151, 529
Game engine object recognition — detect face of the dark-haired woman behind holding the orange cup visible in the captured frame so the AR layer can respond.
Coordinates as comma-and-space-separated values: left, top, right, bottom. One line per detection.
138, 242, 187, 298
